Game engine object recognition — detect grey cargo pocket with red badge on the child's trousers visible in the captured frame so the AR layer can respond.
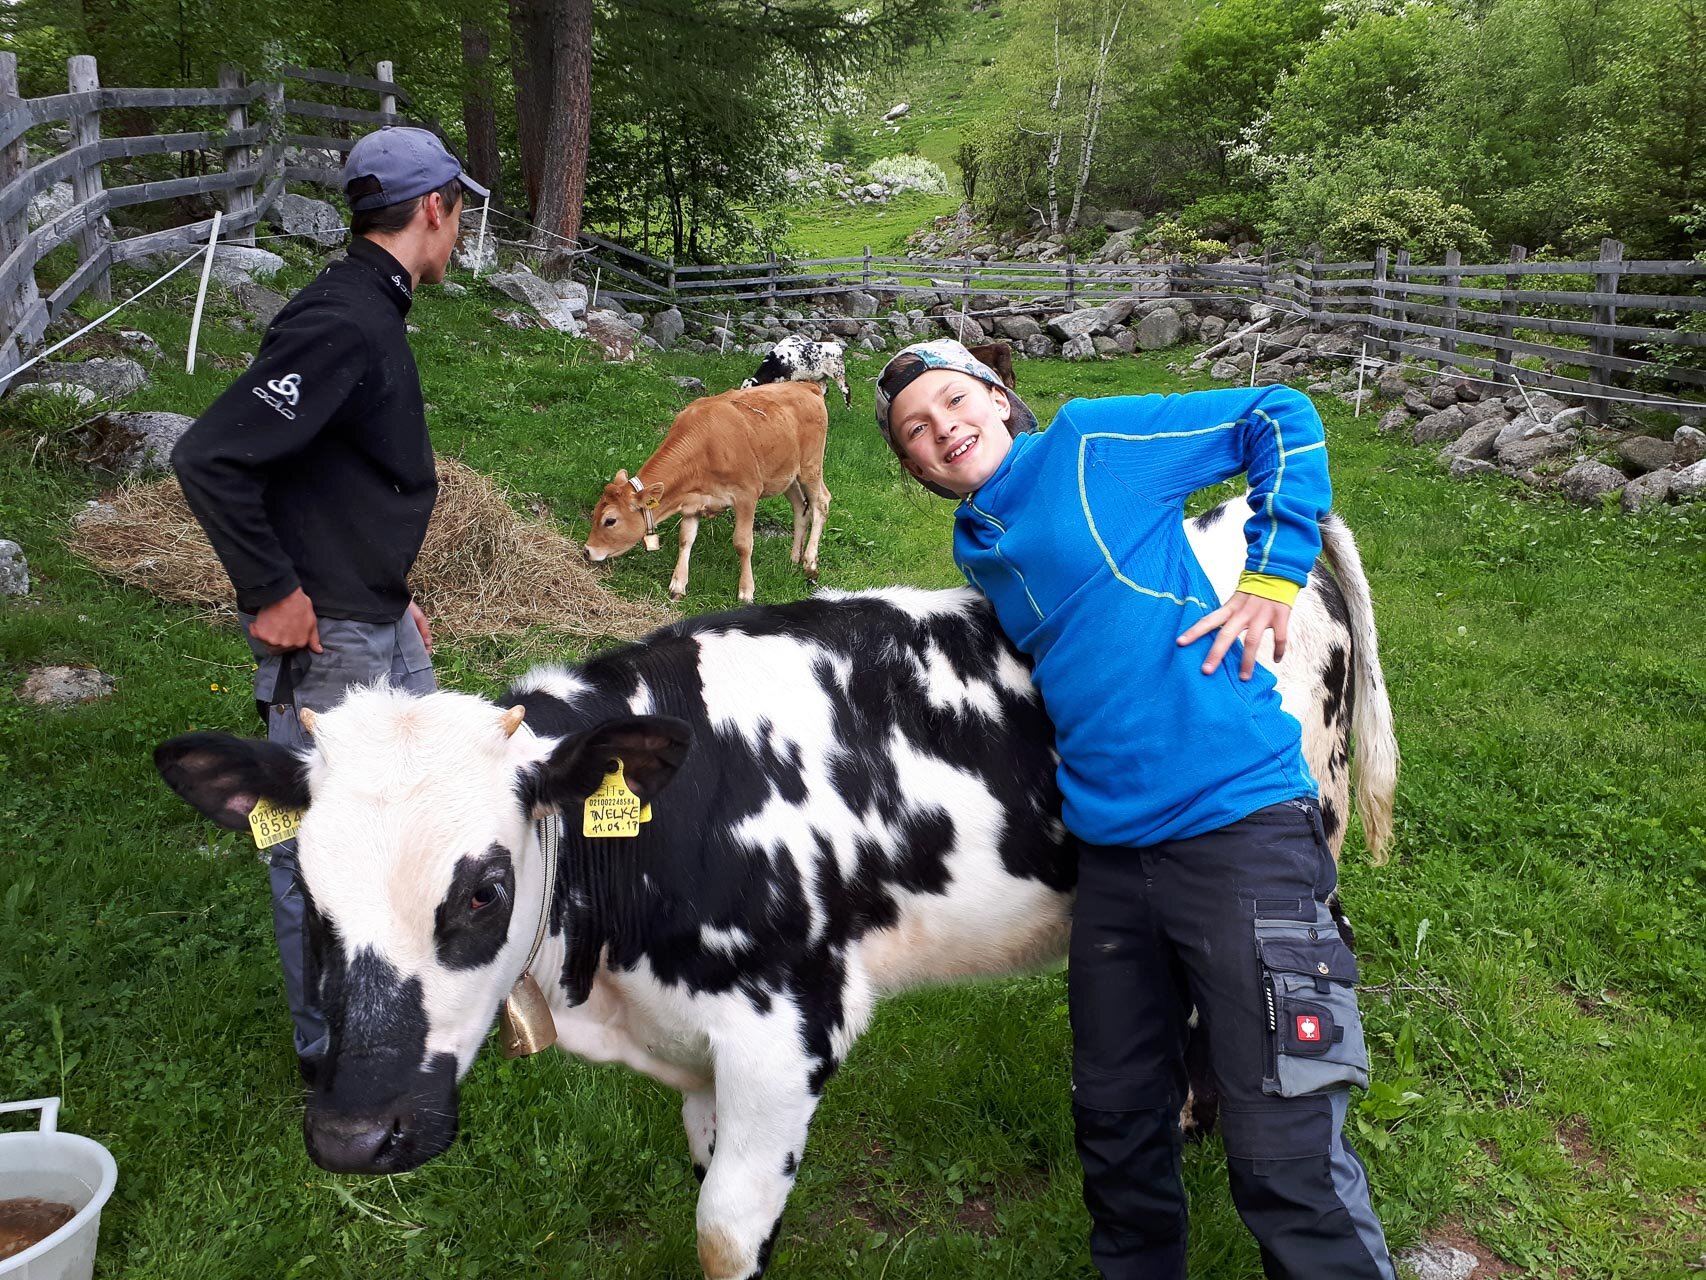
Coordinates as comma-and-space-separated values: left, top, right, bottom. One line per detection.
1256, 905, 1368, 1097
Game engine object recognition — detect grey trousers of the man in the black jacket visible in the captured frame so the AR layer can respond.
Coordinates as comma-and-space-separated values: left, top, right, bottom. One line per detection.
241, 614, 438, 1058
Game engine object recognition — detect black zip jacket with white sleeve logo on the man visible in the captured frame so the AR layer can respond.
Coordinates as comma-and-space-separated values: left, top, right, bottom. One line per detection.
172, 236, 438, 623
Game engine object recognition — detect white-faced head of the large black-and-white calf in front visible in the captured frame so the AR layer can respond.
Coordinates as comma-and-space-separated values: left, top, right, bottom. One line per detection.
154, 688, 688, 1172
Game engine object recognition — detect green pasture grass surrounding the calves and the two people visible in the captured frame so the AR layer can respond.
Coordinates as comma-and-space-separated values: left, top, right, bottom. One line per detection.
0, 271, 1706, 1280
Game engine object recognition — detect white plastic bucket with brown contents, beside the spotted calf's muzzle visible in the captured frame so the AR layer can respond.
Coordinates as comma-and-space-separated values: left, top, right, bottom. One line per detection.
0, 1097, 118, 1280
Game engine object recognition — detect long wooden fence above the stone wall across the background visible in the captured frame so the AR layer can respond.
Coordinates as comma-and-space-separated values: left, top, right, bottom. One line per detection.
583, 236, 1706, 421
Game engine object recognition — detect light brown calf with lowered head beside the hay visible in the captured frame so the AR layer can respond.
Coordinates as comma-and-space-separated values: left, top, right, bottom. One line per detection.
587, 382, 829, 604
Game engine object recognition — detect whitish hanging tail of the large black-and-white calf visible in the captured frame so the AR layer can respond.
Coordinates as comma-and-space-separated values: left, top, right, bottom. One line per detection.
1320, 512, 1399, 864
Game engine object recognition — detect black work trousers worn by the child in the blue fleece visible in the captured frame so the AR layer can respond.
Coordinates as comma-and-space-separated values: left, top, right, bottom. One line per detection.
1068, 800, 1394, 1280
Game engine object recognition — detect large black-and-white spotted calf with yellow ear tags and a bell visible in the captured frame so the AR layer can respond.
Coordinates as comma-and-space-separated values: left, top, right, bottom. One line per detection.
155, 500, 1397, 1280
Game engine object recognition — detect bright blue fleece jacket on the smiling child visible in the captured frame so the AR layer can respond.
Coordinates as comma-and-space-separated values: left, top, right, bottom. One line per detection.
954, 386, 1331, 847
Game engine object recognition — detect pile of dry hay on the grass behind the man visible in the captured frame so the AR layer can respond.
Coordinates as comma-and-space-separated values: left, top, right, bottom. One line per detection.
68, 457, 672, 638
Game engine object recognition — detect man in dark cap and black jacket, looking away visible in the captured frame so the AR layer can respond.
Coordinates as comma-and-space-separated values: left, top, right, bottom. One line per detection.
172, 128, 486, 1079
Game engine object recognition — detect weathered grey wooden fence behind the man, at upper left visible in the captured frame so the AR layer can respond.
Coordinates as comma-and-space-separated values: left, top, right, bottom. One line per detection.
0, 53, 408, 374
